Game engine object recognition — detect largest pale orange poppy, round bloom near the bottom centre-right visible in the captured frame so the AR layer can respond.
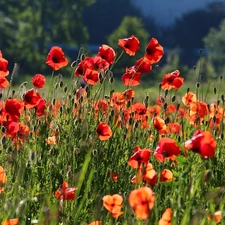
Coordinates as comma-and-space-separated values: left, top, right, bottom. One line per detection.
128, 187, 155, 220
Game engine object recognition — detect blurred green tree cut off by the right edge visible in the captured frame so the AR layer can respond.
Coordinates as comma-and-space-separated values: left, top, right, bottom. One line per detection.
204, 19, 225, 76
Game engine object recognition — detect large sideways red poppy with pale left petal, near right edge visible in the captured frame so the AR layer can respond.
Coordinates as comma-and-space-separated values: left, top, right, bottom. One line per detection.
185, 130, 216, 158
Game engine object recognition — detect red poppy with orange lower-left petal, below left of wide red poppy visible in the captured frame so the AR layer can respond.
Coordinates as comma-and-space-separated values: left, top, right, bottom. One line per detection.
128, 145, 151, 168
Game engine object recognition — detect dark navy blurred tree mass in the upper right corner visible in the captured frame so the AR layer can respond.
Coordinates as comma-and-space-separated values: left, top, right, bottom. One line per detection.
165, 2, 225, 50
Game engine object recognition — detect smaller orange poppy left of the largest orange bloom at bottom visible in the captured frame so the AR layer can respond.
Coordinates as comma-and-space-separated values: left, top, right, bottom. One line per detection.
102, 194, 123, 217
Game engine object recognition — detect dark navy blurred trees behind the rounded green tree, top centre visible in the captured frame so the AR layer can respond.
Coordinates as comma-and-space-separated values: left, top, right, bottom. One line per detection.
84, 0, 156, 44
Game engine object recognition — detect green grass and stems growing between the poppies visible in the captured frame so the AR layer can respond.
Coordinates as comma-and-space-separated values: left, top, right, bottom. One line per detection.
0, 47, 225, 225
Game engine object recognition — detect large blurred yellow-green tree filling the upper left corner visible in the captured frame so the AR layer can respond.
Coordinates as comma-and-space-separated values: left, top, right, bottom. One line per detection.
0, 0, 94, 75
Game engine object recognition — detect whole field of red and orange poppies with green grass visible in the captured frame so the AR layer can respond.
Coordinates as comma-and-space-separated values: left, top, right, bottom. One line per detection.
0, 35, 225, 225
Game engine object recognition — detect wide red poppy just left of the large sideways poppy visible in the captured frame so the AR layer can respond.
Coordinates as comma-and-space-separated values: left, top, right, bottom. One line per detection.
154, 137, 181, 162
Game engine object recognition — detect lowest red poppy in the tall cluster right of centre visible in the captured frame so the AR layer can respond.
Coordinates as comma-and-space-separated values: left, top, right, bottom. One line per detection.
121, 67, 141, 86
